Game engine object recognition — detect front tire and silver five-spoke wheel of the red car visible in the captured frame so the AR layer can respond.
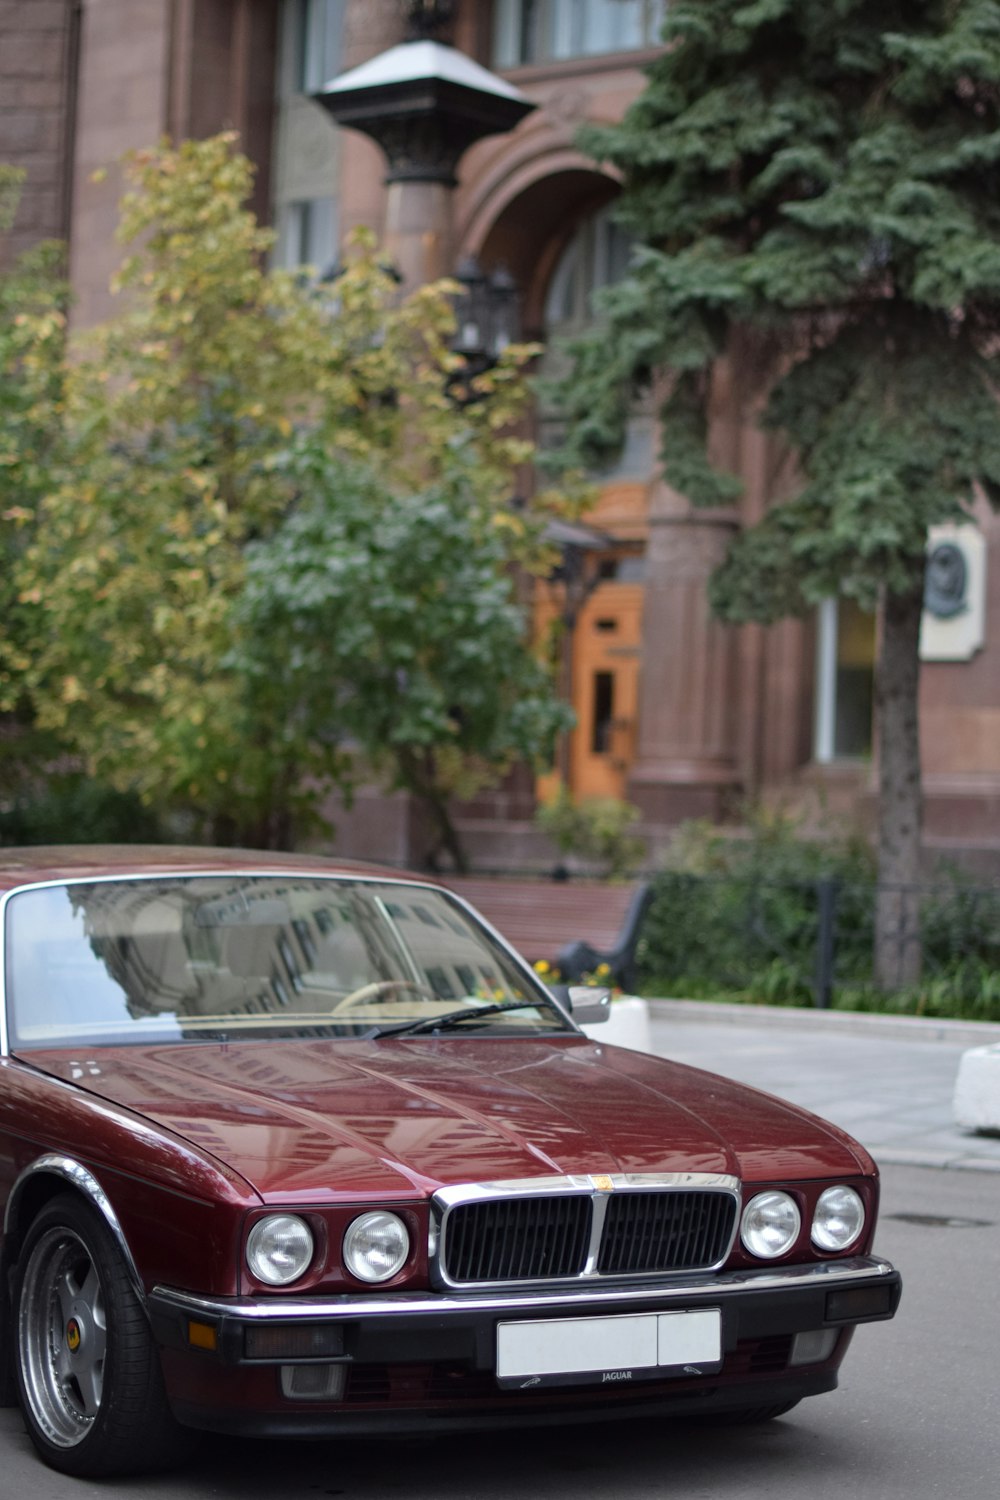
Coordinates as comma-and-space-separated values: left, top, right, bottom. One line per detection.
10, 1194, 177, 1479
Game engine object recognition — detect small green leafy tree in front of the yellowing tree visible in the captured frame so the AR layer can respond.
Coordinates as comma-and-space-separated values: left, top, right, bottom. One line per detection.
229, 453, 568, 870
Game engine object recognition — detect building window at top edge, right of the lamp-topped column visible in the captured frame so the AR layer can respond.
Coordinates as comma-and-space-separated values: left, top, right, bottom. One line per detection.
493, 0, 667, 68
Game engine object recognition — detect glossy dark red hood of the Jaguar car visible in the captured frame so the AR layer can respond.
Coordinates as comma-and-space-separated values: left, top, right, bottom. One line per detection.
31, 1037, 873, 1205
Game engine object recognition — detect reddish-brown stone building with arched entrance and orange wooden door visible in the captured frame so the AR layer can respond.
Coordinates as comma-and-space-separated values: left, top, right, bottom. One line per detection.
0, 0, 1000, 864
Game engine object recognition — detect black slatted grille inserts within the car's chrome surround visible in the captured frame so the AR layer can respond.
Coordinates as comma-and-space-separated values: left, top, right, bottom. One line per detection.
444, 1188, 736, 1284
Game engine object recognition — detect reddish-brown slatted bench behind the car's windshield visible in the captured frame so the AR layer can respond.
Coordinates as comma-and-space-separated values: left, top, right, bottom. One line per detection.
442, 876, 652, 990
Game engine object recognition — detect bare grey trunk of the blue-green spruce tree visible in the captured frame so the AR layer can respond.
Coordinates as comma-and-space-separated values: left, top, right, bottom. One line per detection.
874, 570, 924, 990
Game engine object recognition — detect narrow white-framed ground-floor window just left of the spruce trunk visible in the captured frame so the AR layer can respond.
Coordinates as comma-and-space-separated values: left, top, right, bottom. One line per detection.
814, 599, 876, 765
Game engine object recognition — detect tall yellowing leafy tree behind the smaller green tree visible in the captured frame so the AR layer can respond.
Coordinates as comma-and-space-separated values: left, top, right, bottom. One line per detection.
13, 135, 578, 846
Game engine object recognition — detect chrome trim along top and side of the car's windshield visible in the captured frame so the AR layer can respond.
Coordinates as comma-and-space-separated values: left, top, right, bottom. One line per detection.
0, 866, 583, 1059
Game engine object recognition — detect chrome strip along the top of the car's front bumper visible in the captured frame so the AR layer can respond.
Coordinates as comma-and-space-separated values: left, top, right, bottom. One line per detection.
150, 1256, 897, 1323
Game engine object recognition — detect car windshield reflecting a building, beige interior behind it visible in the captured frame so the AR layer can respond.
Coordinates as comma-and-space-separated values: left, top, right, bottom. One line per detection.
6, 875, 571, 1049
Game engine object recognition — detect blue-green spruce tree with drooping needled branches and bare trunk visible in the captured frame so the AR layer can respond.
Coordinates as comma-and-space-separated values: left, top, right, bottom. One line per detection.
567, 0, 1000, 983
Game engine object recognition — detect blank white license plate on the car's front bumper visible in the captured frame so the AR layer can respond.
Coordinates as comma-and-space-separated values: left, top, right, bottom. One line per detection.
496, 1308, 723, 1388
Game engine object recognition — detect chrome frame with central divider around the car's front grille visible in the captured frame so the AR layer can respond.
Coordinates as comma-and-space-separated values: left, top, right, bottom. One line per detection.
429, 1172, 741, 1290
